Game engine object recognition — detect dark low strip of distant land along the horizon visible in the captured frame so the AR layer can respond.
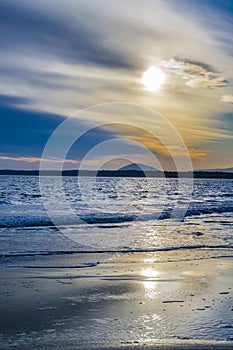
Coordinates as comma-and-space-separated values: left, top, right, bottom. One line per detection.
0, 169, 233, 179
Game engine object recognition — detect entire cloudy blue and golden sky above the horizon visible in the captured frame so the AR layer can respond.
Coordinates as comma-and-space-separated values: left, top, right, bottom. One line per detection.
0, 0, 233, 170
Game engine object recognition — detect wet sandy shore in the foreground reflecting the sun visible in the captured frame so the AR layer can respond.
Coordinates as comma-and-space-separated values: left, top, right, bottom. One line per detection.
0, 251, 233, 350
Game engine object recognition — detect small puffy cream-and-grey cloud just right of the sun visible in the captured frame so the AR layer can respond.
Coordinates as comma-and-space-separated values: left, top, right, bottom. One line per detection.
160, 58, 227, 89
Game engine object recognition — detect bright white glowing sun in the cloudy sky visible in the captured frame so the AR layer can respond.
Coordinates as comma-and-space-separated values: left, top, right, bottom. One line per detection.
141, 66, 165, 92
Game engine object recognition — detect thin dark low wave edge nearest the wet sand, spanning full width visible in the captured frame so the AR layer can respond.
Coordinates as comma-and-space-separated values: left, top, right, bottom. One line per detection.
0, 244, 233, 258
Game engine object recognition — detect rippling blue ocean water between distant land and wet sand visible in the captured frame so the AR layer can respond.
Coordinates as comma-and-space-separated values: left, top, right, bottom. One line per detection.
0, 176, 233, 262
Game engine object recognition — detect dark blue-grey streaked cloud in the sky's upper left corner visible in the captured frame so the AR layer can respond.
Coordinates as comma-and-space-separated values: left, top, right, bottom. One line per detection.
0, 0, 137, 69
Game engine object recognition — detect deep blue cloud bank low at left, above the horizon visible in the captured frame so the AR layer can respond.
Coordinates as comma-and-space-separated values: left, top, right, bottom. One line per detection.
0, 95, 115, 160
